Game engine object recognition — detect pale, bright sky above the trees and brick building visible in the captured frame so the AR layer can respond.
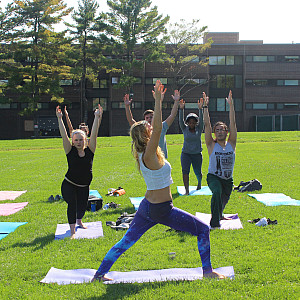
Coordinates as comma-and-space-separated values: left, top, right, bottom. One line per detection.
1, 0, 300, 44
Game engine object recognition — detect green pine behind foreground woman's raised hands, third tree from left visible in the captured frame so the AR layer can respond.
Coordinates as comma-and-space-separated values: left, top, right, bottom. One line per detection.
107, 0, 169, 90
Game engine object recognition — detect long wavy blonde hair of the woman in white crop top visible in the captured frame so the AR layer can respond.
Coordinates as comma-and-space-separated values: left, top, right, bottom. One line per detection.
130, 121, 165, 170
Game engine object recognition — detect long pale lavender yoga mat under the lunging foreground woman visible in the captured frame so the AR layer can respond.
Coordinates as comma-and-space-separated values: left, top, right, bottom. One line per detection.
40, 266, 234, 285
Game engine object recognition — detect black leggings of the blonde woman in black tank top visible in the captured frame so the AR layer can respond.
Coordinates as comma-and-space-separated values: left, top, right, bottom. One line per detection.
61, 180, 90, 224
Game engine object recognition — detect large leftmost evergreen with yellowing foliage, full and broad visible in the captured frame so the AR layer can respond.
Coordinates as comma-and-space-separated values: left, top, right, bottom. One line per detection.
2, 0, 72, 113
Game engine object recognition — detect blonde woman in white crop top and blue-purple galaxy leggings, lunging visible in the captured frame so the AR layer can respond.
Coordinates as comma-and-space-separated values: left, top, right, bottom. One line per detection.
92, 80, 225, 281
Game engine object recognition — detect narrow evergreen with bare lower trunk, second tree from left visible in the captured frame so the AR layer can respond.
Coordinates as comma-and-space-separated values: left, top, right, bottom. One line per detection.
66, 0, 106, 123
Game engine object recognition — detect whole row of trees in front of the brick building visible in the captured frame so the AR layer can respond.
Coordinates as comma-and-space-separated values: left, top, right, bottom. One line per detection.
0, 0, 211, 120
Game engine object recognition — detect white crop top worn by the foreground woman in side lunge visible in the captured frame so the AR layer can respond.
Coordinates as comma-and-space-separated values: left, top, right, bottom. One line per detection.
139, 153, 173, 191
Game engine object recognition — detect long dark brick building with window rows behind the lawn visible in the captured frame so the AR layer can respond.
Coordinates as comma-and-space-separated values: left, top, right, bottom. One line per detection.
0, 33, 300, 139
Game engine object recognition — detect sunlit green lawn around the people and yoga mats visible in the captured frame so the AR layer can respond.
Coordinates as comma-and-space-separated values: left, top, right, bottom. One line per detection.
0, 132, 300, 300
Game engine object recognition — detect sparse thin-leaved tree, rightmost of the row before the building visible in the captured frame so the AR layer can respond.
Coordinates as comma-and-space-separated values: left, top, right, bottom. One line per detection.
166, 19, 212, 96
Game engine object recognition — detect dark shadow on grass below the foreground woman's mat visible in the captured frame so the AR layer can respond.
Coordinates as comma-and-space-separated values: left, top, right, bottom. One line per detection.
86, 281, 182, 300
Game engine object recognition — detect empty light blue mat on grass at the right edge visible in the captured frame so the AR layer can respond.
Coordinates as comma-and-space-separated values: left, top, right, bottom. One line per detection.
248, 193, 300, 206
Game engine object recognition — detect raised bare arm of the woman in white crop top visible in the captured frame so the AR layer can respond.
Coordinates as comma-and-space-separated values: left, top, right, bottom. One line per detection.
143, 80, 166, 165
